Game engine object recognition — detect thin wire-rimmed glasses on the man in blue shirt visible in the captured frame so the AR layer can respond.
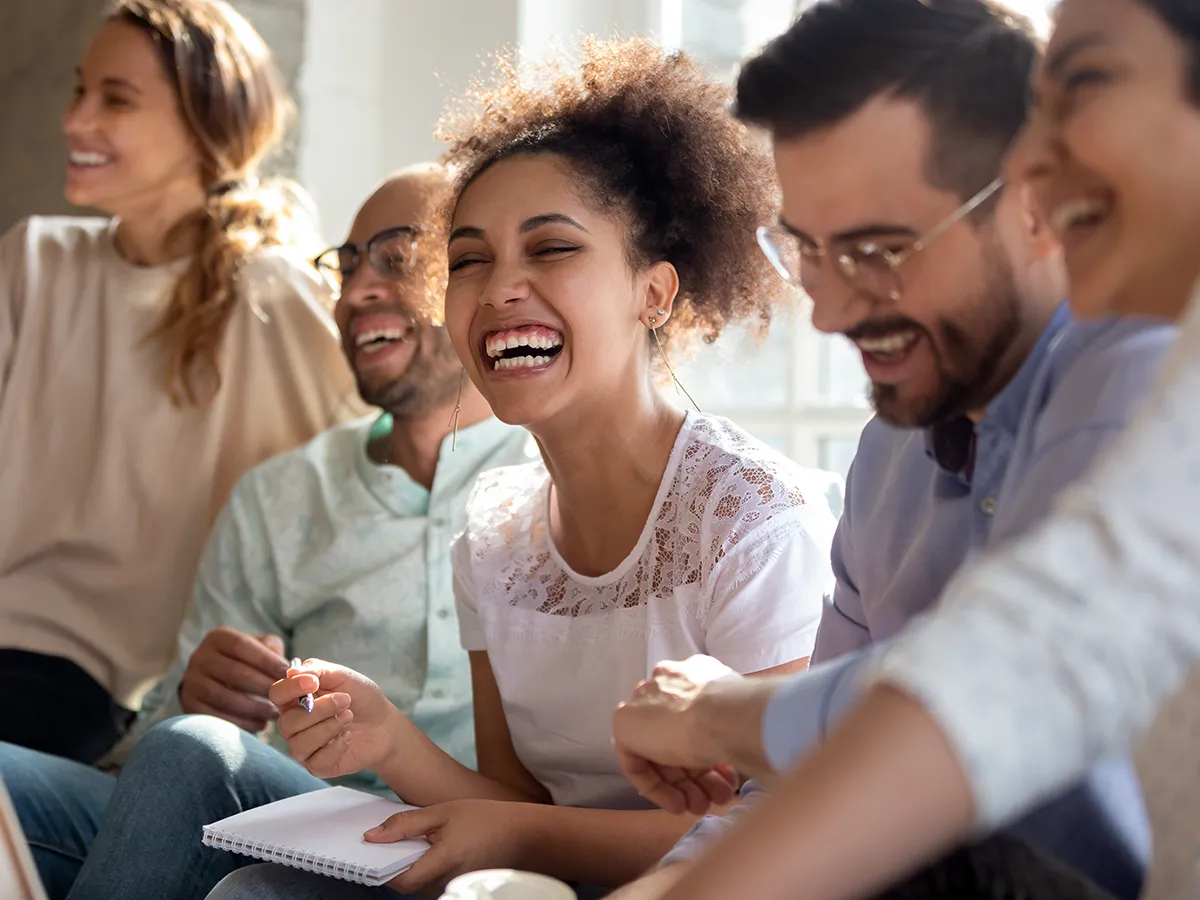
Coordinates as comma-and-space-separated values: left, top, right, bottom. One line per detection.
757, 176, 1004, 301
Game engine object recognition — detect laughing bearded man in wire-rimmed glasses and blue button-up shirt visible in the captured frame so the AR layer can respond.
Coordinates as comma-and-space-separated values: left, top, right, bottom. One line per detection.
614, 0, 1174, 900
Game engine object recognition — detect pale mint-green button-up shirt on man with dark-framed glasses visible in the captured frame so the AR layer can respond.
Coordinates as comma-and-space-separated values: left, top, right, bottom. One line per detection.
144, 416, 536, 792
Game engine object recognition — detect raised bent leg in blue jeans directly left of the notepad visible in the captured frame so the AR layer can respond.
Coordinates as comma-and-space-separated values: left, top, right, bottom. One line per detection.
60, 715, 328, 900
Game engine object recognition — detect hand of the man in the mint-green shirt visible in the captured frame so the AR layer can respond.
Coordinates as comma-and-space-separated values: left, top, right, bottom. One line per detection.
179, 628, 288, 734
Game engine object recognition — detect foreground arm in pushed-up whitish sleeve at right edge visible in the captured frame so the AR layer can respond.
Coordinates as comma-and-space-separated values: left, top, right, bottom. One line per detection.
667, 297, 1200, 900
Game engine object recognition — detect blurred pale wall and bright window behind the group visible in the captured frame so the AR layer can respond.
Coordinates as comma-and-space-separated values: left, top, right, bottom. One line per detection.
0, 0, 1044, 487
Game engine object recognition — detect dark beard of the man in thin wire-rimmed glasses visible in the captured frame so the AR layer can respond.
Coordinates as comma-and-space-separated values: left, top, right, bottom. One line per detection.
870, 242, 1021, 428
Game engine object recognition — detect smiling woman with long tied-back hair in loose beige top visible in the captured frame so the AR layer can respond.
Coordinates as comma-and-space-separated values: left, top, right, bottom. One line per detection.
0, 0, 353, 763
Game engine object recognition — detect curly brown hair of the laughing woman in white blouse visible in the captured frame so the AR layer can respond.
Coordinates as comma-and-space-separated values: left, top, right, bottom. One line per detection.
438, 40, 786, 342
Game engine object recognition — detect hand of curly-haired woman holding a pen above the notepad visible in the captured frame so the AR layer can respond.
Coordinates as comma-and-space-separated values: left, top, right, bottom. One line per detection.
270, 659, 402, 778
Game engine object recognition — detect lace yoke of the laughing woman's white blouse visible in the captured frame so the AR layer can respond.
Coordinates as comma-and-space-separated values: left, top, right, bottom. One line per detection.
467, 415, 805, 618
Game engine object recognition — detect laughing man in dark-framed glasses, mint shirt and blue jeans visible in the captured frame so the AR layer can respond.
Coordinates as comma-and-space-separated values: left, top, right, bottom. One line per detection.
0, 166, 536, 900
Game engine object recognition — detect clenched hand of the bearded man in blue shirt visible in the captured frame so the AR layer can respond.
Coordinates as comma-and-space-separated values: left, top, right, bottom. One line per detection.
613, 655, 774, 815
